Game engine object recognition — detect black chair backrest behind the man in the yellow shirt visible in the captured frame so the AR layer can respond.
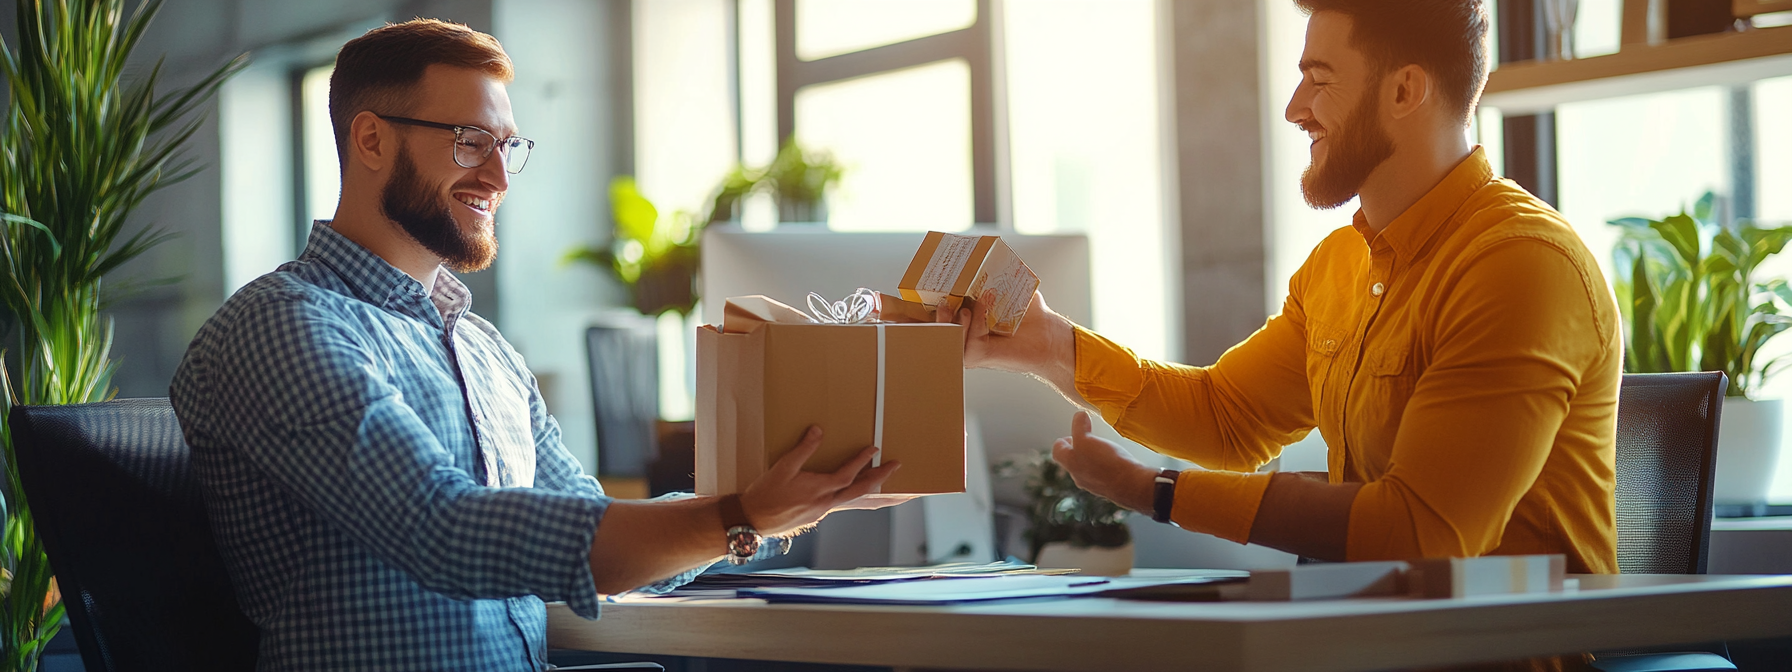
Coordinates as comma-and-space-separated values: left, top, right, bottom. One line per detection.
1618, 371, 1729, 573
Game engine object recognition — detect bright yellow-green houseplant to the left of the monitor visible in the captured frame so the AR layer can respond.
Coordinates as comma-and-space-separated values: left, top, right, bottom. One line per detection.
564, 176, 702, 315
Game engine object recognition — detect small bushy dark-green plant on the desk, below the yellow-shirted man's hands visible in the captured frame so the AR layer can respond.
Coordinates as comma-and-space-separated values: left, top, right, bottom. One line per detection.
998, 450, 1133, 563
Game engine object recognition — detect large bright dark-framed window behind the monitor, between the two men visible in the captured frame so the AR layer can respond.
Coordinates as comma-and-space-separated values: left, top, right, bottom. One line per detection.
715, 0, 1174, 357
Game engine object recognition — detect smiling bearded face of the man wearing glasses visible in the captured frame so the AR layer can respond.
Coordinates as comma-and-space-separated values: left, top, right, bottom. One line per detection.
380, 65, 516, 272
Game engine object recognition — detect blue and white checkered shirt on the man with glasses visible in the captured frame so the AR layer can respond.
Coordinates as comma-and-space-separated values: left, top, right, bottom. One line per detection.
170, 222, 609, 670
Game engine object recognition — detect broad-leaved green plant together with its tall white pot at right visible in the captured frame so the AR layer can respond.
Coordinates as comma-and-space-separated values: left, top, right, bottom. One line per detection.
1611, 192, 1792, 505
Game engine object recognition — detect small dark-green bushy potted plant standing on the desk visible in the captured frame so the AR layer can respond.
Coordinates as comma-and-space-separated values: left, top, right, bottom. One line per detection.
998, 450, 1133, 575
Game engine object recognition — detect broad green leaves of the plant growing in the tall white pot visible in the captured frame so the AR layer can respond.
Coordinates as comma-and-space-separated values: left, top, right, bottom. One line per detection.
1611, 192, 1792, 398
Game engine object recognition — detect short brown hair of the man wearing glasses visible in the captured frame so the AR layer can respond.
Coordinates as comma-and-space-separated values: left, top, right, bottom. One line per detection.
330, 18, 514, 161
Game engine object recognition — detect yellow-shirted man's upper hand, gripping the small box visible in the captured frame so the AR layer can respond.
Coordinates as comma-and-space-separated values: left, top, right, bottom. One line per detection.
934, 292, 1090, 409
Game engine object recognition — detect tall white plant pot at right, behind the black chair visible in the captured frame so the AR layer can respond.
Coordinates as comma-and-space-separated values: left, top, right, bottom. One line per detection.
1711, 396, 1785, 504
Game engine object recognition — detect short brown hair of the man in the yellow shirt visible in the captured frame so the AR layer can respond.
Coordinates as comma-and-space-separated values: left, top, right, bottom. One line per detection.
1294, 0, 1487, 124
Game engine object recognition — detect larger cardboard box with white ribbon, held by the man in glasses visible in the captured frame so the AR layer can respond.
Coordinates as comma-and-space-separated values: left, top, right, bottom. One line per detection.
697, 297, 964, 495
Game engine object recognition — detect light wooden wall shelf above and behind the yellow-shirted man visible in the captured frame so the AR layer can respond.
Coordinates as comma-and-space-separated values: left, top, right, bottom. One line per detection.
1480, 27, 1792, 115
